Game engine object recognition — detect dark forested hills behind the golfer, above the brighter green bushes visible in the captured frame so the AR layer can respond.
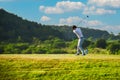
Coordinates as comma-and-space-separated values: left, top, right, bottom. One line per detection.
0, 9, 118, 42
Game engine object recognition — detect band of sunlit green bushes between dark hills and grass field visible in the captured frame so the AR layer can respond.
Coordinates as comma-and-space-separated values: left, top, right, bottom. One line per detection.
0, 37, 120, 54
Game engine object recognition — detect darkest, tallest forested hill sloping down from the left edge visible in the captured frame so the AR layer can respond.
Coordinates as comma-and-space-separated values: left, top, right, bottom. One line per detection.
0, 9, 63, 42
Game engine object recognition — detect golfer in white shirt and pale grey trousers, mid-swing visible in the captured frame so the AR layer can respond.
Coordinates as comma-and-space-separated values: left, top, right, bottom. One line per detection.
72, 25, 87, 56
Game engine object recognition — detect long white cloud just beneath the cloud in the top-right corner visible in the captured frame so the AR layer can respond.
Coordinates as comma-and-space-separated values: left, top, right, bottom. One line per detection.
83, 6, 116, 15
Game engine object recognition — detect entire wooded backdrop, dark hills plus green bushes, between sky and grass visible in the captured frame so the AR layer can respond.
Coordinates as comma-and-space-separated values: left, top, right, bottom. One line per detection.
0, 9, 120, 54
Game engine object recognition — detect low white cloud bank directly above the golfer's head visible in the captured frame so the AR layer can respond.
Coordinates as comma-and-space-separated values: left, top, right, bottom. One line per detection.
59, 16, 104, 27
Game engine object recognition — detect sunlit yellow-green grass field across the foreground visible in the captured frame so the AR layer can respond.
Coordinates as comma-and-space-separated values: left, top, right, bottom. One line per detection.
0, 54, 120, 80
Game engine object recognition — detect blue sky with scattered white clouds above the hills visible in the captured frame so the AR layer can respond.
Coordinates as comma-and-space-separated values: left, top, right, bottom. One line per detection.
0, 0, 120, 34
